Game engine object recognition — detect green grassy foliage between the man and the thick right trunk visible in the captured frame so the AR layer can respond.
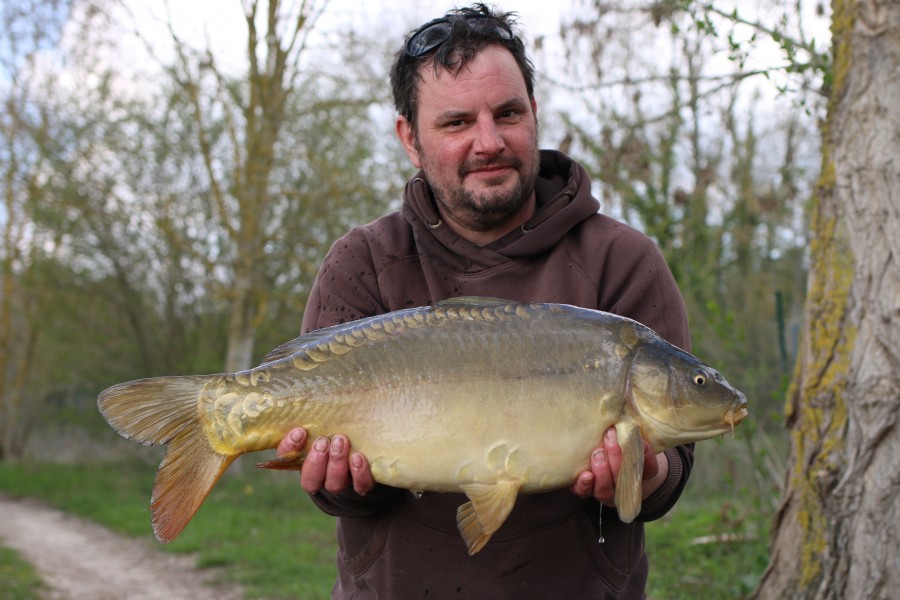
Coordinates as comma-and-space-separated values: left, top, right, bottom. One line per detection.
646, 400, 789, 600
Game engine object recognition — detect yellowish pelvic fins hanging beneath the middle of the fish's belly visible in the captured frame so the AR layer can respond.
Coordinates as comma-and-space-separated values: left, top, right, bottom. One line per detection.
456, 481, 520, 556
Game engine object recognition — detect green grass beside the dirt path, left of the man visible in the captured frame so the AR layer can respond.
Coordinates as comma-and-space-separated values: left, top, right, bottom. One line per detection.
0, 454, 336, 600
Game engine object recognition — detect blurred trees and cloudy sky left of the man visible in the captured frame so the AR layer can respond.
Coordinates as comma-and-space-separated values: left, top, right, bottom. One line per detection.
0, 0, 404, 457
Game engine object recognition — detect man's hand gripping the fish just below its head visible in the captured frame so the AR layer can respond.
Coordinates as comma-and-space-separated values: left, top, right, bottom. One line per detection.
571, 427, 669, 506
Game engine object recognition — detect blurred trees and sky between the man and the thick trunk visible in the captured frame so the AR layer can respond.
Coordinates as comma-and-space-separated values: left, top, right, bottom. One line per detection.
545, 0, 829, 511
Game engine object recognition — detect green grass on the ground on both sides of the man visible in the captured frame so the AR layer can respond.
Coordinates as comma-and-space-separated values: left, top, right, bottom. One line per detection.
0, 434, 773, 600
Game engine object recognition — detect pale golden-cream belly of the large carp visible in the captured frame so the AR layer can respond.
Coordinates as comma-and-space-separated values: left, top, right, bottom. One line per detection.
288, 379, 615, 492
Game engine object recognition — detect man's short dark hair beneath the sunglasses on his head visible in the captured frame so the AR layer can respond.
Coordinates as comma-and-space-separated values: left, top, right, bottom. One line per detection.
391, 2, 534, 131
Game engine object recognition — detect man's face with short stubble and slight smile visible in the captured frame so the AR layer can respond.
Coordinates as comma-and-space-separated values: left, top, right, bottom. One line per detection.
397, 46, 539, 233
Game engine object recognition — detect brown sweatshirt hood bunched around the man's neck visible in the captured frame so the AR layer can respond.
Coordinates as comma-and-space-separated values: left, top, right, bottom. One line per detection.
402, 150, 600, 273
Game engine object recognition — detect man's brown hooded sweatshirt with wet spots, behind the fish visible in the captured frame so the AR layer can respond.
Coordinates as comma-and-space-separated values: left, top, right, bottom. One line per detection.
303, 151, 693, 600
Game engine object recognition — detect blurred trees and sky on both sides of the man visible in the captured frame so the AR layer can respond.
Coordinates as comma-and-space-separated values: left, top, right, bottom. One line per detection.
0, 0, 827, 544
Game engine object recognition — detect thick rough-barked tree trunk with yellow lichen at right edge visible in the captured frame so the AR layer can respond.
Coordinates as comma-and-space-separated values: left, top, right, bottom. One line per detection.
756, 0, 900, 600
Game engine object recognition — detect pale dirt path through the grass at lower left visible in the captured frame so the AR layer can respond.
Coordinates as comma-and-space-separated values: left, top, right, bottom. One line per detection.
0, 494, 241, 600
